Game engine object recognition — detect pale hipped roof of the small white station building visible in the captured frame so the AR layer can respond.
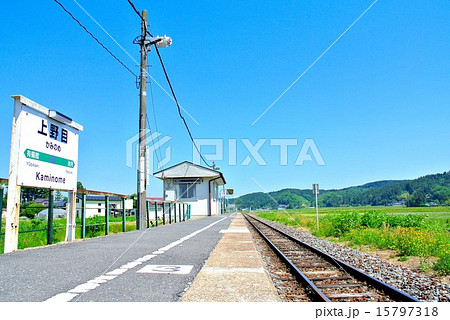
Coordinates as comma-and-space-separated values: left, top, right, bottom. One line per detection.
153, 161, 226, 184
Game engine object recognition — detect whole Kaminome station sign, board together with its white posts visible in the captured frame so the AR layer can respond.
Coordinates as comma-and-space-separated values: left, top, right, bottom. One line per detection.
4, 95, 83, 253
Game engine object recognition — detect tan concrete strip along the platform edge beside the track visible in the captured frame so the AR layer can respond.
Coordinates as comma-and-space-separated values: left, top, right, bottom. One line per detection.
181, 214, 280, 302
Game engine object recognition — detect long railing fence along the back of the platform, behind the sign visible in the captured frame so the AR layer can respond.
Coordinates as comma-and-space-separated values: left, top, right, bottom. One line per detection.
0, 178, 191, 252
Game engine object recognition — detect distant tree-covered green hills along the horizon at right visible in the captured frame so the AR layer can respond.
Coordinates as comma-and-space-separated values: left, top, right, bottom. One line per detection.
230, 171, 450, 209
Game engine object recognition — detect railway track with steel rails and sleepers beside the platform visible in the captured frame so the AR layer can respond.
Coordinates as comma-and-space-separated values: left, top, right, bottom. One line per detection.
244, 214, 419, 302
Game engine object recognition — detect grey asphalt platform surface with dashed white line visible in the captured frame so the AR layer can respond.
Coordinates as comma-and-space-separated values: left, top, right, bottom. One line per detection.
0, 215, 231, 302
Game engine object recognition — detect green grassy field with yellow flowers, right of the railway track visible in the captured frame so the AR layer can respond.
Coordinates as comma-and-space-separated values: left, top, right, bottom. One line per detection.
255, 207, 450, 275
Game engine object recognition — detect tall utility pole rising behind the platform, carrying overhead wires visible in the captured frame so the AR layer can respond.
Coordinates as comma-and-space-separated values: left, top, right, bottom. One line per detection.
136, 10, 147, 230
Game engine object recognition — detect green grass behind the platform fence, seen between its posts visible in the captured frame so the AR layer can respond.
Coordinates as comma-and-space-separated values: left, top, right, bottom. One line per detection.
0, 216, 136, 253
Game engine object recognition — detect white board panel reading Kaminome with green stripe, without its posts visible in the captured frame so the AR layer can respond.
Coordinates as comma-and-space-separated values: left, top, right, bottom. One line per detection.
15, 97, 81, 190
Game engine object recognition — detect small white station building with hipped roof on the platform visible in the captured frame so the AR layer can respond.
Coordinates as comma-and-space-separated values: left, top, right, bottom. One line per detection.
153, 161, 226, 216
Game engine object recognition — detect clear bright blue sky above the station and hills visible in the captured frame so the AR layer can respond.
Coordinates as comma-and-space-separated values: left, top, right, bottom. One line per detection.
0, 0, 450, 196
